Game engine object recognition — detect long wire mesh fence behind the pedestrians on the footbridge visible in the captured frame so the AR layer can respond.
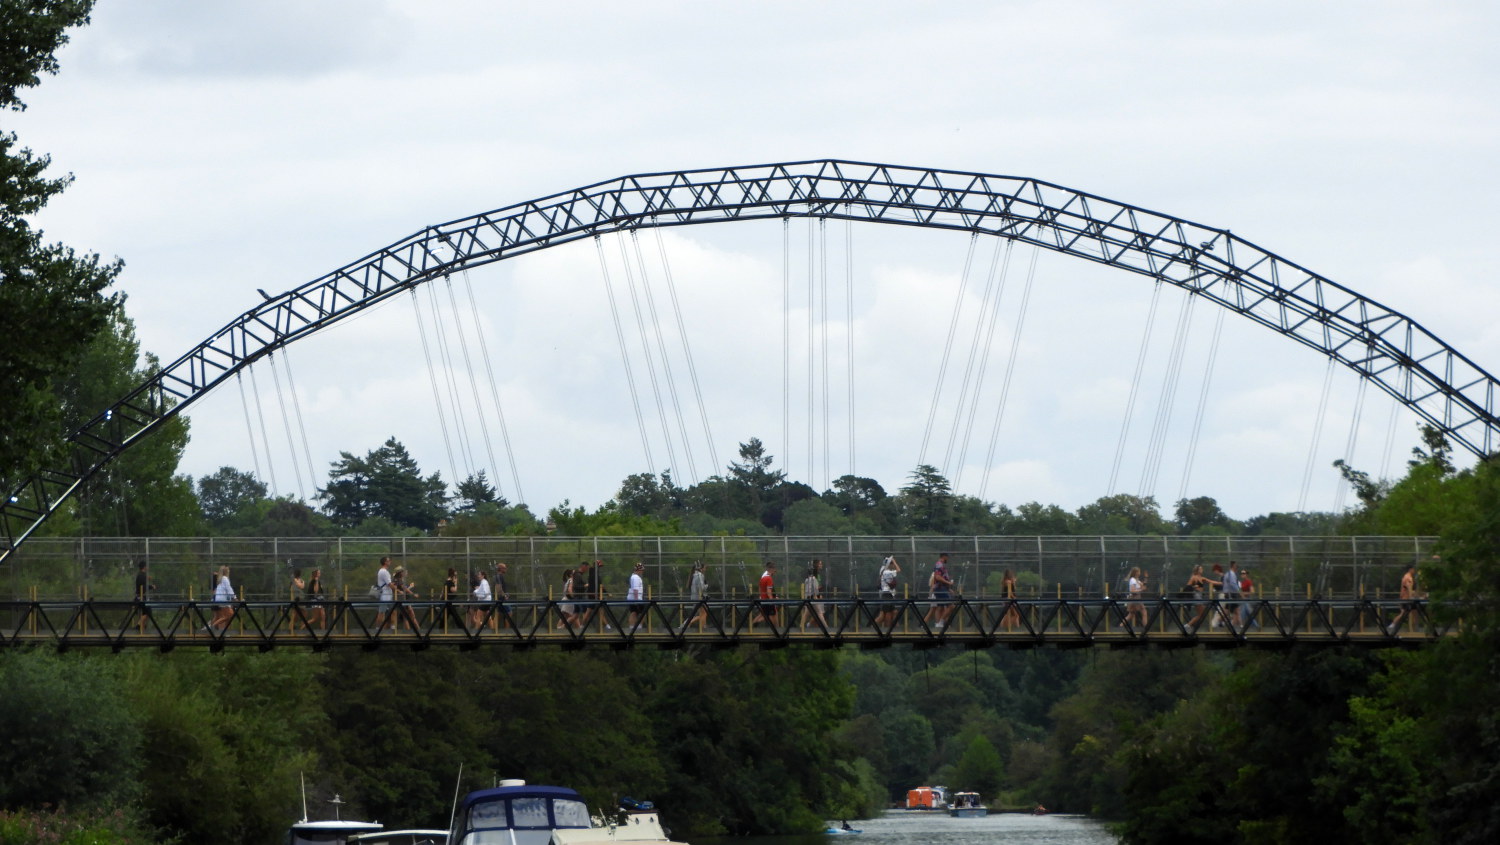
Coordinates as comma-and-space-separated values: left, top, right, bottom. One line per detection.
0, 536, 1437, 600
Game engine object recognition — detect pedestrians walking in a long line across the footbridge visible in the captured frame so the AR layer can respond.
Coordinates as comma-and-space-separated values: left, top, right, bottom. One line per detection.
134, 552, 1425, 636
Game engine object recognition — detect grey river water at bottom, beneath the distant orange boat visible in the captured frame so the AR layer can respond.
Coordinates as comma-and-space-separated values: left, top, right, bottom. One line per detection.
711, 810, 1116, 845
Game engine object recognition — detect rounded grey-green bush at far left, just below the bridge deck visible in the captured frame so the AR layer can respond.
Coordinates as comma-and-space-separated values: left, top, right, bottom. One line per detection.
0, 650, 143, 809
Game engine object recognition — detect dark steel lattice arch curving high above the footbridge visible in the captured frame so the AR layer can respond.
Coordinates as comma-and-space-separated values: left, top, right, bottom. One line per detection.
0, 159, 1500, 561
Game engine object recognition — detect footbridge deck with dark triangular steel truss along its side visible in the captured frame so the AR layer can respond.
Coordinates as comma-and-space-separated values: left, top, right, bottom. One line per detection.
0, 597, 1451, 651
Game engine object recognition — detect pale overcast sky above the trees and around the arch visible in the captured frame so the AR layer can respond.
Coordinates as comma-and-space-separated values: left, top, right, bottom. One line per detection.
6, 0, 1500, 518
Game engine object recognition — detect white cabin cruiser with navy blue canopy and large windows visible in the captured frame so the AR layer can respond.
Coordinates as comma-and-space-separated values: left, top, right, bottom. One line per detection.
449, 780, 683, 845
